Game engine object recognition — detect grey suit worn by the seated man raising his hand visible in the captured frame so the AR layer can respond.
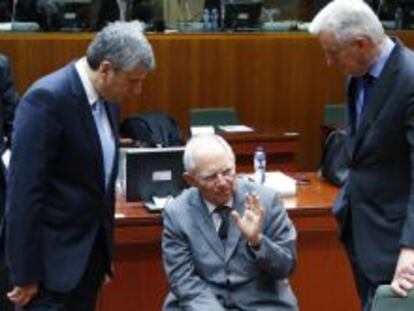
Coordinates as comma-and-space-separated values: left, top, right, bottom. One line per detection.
162, 179, 298, 311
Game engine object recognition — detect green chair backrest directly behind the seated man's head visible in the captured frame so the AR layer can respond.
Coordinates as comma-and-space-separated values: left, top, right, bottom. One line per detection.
190, 107, 239, 127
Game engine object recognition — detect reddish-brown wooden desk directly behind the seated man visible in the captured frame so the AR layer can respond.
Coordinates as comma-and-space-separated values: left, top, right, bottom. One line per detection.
100, 173, 358, 311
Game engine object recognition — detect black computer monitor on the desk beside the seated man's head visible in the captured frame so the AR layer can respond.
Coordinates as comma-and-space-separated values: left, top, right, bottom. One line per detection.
120, 147, 185, 202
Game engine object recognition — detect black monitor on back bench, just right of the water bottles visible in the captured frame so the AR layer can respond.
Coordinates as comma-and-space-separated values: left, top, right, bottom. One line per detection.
224, 0, 263, 30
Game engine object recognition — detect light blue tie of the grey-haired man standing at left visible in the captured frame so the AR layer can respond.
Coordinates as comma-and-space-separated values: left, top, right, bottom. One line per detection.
92, 101, 115, 187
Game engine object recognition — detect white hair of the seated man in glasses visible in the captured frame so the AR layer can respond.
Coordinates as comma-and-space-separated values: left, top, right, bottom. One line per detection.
183, 134, 236, 173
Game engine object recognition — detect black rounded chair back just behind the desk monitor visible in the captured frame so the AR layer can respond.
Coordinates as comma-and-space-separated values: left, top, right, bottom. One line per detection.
120, 113, 183, 147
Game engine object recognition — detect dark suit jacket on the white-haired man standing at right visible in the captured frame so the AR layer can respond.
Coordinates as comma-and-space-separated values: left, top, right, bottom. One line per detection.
334, 42, 414, 284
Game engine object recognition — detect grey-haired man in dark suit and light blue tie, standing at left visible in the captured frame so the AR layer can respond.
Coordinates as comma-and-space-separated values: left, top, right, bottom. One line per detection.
5, 22, 155, 311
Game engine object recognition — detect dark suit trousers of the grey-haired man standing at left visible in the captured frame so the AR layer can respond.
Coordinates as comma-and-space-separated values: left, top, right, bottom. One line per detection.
16, 233, 109, 311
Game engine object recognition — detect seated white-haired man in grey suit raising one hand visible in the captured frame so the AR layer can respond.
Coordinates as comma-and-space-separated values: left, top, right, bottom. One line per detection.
162, 135, 298, 311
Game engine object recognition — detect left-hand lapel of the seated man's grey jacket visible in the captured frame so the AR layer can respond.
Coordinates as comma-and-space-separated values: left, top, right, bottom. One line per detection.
190, 191, 224, 260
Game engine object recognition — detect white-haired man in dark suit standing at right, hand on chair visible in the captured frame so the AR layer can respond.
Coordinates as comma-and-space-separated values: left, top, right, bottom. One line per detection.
310, 0, 414, 310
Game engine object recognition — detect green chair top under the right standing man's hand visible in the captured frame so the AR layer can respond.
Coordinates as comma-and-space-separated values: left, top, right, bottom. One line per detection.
371, 285, 414, 311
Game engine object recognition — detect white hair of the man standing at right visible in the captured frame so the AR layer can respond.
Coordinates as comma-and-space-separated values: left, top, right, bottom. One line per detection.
309, 0, 386, 45
